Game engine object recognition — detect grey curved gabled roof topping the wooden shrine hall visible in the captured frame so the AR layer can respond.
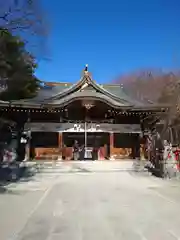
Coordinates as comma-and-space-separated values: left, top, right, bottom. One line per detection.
2, 68, 167, 108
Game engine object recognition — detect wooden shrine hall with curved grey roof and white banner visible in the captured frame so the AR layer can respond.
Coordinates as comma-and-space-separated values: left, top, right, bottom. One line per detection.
0, 66, 166, 160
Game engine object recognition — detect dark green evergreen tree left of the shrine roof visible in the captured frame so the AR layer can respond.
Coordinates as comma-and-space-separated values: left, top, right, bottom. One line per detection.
0, 28, 39, 100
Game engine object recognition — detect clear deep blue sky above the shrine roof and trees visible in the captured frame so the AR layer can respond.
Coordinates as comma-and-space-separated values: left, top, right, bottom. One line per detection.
36, 0, 180, 83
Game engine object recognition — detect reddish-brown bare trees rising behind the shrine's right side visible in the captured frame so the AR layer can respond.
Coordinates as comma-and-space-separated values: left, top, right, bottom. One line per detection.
116, 70, 180, 143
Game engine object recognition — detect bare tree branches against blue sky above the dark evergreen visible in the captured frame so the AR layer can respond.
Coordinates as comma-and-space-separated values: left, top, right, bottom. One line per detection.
0, 0, 48, 58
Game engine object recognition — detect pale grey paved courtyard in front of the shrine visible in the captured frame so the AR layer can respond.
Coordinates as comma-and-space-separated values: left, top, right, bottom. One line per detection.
0, 162, 180, 240
